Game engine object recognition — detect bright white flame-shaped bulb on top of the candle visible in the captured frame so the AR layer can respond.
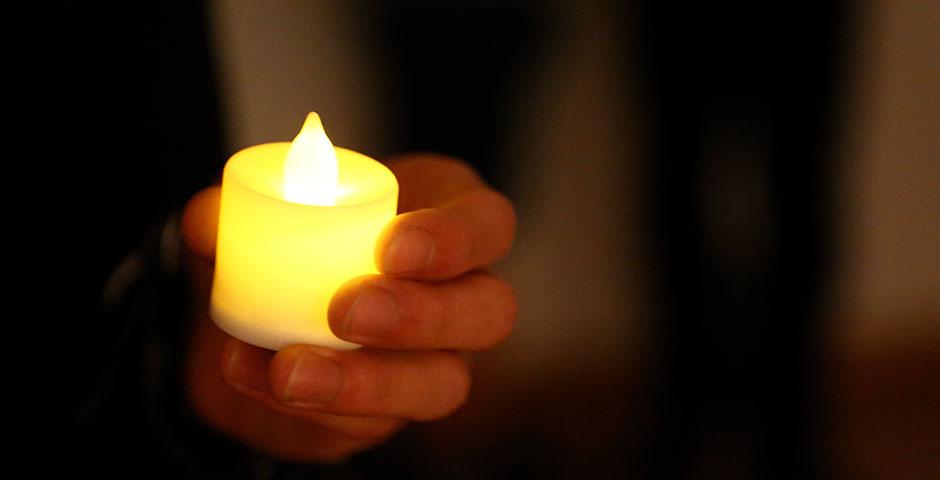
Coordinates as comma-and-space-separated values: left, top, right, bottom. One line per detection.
284, 112, 339, 205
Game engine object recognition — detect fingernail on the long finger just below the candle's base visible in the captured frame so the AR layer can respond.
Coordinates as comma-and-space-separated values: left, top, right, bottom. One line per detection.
282, 352, 345, 404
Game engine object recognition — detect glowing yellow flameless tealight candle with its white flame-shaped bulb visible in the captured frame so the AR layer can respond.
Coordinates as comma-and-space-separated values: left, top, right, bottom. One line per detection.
210, 113, 398, 350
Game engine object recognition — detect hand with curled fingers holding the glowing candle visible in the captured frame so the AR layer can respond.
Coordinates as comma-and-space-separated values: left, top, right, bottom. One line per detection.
176, 154, 516, 463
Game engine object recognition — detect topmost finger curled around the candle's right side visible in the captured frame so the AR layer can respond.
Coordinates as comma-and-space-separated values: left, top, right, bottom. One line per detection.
376, 154, 516, 280
